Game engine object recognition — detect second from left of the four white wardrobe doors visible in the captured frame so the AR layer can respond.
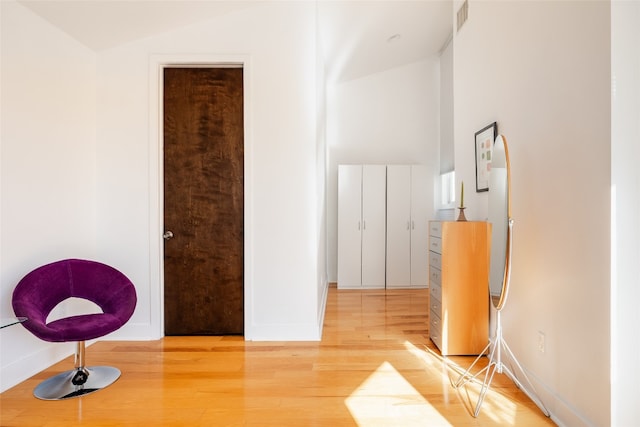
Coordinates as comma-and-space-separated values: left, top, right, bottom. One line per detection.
362, 165, 387, 288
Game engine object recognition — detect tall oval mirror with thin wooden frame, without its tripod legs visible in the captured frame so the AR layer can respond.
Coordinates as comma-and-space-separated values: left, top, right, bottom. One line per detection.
488, 135, 513, 310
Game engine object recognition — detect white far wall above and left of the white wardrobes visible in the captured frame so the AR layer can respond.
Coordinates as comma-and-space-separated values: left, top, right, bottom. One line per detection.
327, 58, 440, 282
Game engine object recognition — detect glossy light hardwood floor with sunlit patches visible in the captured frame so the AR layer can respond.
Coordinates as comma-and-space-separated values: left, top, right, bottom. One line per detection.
0, 287, 554, 427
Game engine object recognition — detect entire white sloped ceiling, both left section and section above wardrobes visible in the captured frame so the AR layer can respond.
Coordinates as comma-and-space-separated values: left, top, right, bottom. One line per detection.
19, 0, 452, 80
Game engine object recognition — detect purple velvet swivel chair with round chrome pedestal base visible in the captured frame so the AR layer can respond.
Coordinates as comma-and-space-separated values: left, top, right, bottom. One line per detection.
12, 259, 137, 400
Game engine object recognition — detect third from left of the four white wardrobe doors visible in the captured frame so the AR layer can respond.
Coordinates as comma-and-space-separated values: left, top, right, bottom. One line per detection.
386, 165, 412, 288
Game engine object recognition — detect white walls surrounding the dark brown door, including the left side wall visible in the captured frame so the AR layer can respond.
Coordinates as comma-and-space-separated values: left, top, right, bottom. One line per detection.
0, 1, 326, 389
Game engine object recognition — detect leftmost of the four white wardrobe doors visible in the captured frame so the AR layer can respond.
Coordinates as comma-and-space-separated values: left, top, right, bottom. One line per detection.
338, 165, 362, 288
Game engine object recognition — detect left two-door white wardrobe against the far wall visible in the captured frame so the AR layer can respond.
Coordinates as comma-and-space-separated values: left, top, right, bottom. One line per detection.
338, 165, 387, 289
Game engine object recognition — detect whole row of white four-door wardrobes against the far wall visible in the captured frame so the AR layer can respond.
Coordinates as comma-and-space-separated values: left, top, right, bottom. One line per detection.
338, 165, 429, 289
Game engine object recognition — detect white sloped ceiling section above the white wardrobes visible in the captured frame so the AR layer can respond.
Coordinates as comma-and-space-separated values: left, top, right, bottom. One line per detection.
318, 0, 453, 80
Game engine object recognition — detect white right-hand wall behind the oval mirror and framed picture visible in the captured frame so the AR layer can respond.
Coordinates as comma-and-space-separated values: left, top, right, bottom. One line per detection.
454, 1, 611, 426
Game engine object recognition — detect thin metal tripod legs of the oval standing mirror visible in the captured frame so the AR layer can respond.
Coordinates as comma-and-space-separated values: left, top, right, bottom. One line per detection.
454, 310, 550, 418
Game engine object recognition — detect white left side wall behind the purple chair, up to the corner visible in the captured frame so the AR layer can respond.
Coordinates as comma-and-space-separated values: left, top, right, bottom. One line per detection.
0, 1, 98, 391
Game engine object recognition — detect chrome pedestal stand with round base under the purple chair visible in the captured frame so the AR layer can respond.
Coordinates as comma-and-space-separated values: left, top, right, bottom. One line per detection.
33, 341, 120, 400
